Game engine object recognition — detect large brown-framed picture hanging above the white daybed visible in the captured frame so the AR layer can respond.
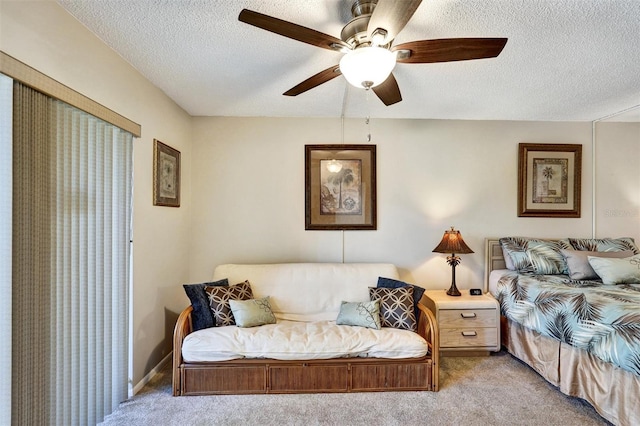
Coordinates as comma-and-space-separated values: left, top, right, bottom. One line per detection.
304, 145, 376, 230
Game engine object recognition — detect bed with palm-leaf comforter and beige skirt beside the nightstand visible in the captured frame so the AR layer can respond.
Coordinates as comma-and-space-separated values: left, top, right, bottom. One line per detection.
485, 238, 640, 425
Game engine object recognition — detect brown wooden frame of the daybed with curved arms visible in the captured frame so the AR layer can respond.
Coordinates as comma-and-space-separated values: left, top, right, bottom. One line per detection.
173, 304, 440, 396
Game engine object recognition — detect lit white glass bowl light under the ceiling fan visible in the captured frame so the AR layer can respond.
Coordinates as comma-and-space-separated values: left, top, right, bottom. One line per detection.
340, 46, 396, 89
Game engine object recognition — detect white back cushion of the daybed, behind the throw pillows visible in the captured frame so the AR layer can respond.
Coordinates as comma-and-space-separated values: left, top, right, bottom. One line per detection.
213, 263, 398, 321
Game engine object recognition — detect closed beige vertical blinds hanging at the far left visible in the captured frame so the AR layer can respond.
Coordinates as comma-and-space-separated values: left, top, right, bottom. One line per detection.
11, 82, 133, 425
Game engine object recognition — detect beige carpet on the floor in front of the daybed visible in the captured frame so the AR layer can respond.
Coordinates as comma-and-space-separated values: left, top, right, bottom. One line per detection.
104, 352, 609, 426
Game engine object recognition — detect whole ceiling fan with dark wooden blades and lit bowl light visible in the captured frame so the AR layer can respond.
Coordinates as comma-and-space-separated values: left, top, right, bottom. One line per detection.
238, 0, 507, 106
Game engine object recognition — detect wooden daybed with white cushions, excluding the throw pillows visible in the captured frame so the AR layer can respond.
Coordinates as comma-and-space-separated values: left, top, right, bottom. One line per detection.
173, 263, 439, 396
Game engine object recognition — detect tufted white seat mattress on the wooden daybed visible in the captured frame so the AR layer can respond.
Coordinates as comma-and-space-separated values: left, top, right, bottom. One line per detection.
182, 320, 428, 362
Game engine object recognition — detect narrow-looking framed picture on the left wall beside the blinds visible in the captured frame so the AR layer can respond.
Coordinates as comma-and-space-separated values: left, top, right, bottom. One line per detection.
153, 139, 180, 207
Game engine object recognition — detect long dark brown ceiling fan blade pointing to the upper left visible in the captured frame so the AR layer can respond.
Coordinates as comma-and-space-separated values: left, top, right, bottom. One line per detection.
238, 9, 351, 51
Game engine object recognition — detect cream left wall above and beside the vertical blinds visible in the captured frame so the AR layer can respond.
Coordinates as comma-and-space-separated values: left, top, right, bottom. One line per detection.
0, 1, 191, 385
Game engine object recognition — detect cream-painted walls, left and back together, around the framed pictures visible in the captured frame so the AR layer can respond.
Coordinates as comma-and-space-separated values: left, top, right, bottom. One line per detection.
0, 1, 640, 394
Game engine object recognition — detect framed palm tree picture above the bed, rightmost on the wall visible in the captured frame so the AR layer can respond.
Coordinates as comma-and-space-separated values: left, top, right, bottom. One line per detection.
518, 143, 582, 218
